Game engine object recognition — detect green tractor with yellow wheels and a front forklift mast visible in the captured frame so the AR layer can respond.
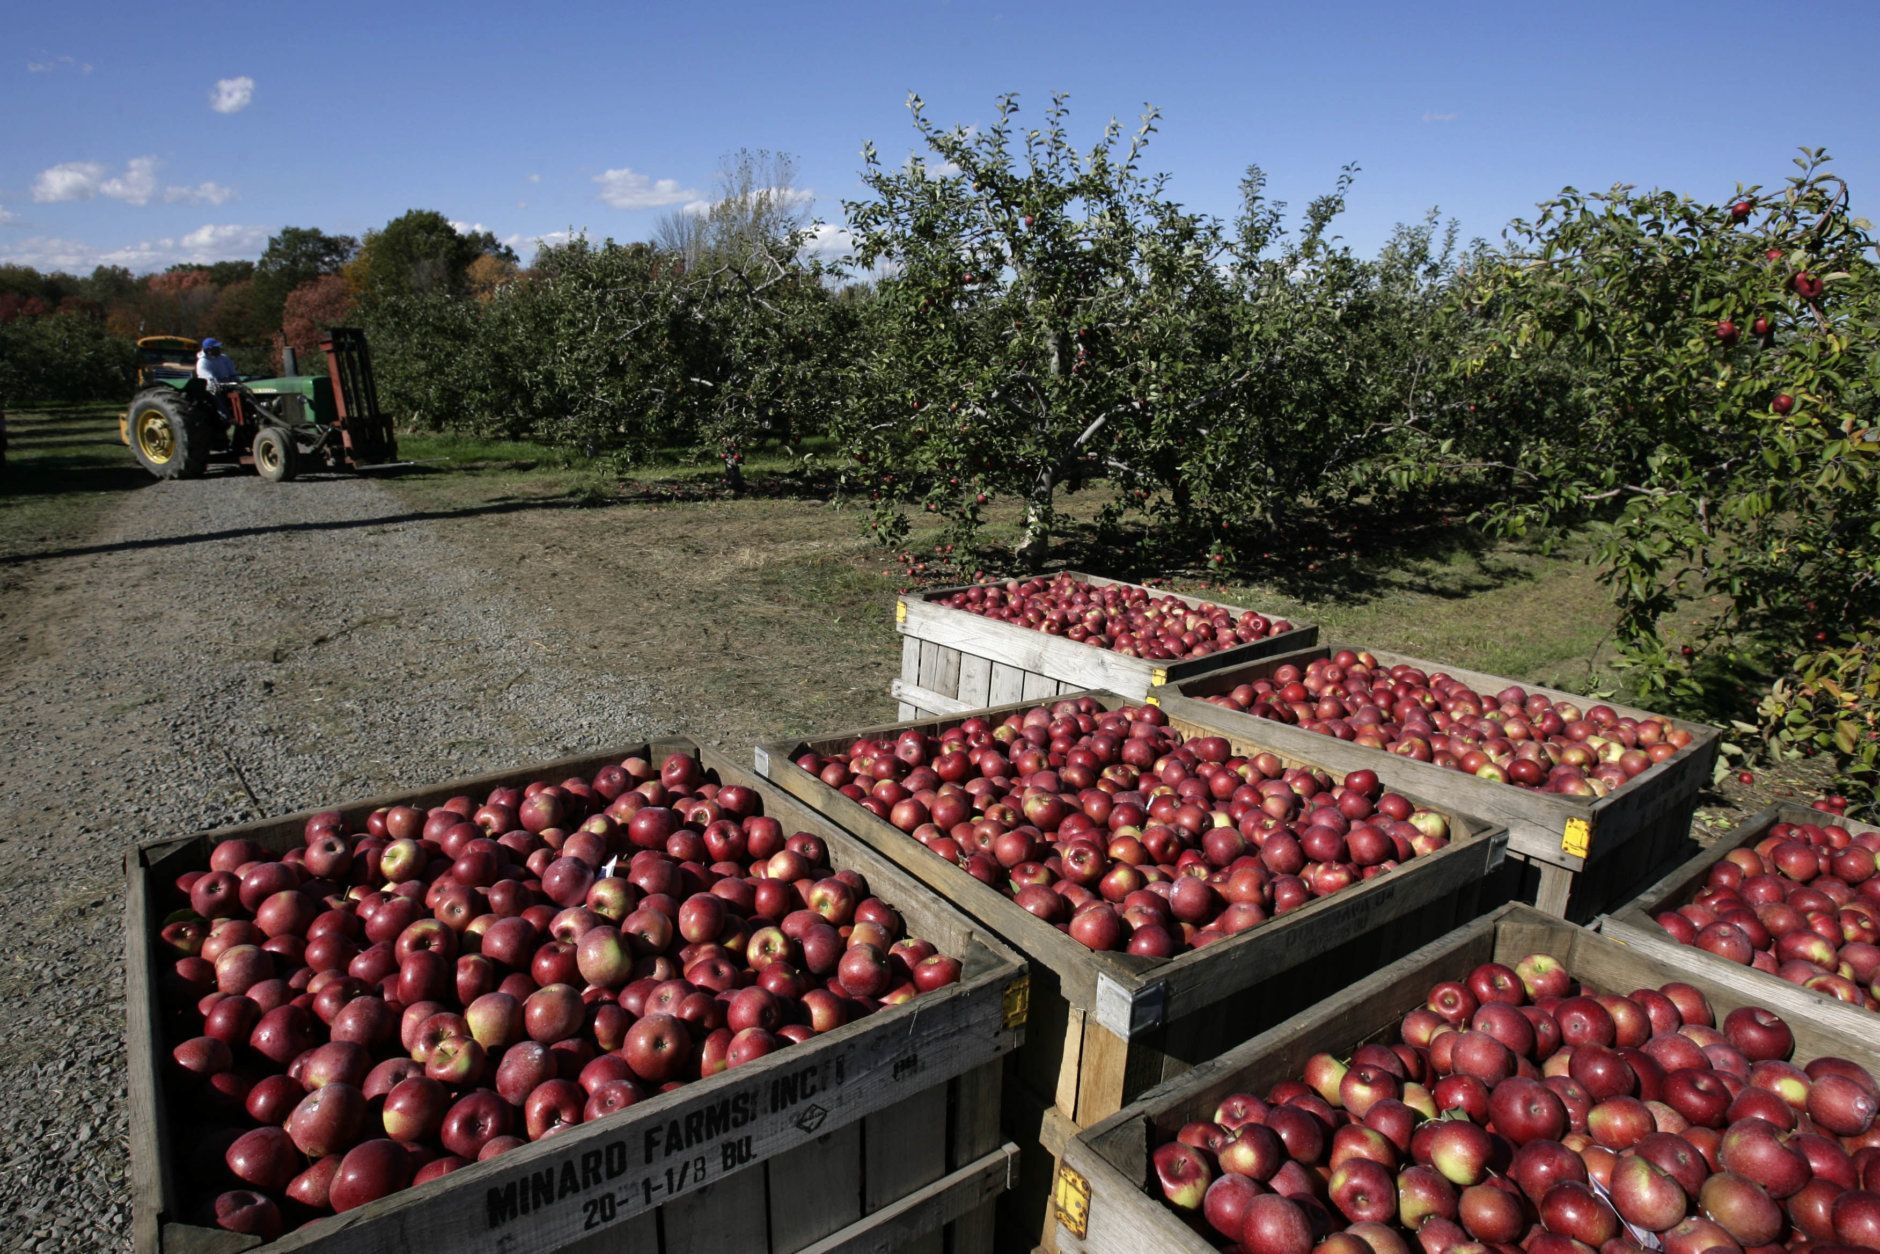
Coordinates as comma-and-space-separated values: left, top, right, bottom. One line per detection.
118, 327, 406, 483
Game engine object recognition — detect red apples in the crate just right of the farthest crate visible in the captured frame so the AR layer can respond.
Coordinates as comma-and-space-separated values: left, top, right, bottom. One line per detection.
1207, 649, 1690, 797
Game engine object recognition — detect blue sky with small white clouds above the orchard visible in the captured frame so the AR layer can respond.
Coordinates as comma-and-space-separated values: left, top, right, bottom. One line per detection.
0, 0, 1880, 271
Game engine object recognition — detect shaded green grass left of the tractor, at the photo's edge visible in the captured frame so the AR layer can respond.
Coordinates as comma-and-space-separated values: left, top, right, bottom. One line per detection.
0, 404, 152, 556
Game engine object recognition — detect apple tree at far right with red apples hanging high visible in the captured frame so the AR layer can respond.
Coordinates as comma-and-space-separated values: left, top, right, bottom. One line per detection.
1408, 150, 1880, 808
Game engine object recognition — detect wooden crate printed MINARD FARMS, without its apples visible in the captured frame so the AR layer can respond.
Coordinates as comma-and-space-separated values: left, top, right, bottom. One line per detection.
126, 741, 1028, 1254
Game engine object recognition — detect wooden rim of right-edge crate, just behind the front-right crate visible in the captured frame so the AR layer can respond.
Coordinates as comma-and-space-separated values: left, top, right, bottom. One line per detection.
1600, 805, 1880, 1036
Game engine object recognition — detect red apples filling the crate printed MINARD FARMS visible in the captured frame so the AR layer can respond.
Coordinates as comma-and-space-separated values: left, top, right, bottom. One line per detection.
158, 754, 961, 1239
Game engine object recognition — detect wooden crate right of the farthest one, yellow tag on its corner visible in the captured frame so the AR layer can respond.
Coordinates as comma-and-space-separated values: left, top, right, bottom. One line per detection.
1158, 643, 1718, 923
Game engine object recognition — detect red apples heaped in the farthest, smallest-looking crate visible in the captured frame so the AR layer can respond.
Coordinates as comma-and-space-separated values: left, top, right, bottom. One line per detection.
940, 575, 1293, 662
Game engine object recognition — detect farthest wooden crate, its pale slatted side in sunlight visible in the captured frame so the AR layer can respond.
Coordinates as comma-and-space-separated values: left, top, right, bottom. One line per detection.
891, 572, 1318, 718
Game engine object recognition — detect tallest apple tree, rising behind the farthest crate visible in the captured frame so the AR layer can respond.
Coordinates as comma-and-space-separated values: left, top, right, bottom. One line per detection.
835, 96, 1226, 566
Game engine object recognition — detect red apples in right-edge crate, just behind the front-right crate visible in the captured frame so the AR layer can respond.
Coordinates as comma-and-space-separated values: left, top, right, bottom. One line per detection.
1656, 814, 1880, 1010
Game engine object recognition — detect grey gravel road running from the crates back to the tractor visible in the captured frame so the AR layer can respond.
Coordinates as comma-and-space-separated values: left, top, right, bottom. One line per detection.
0, 476, 673, 1250
